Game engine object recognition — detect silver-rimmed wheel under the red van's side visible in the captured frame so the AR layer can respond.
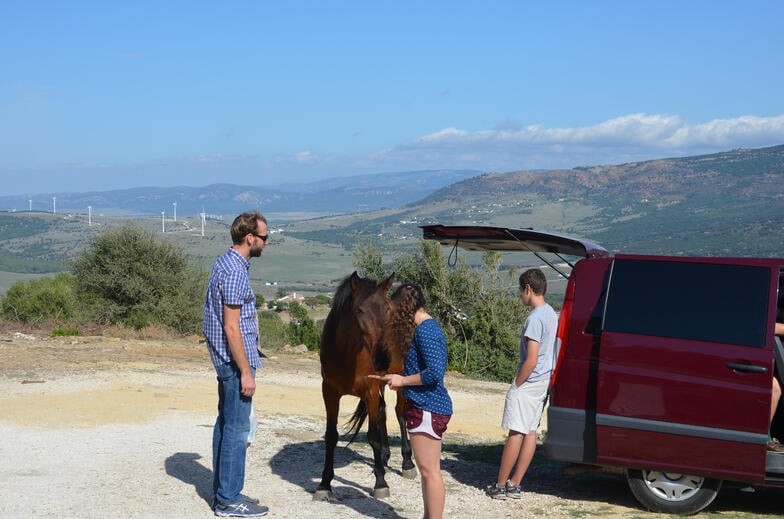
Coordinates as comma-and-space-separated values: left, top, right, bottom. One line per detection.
626, 469, 721, 515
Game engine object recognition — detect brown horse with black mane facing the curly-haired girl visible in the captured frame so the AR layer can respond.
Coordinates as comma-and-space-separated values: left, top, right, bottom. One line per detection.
313, 271, 416, 501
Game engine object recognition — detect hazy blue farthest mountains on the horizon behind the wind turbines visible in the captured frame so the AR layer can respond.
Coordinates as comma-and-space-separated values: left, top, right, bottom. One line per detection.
0, 170, 481, 220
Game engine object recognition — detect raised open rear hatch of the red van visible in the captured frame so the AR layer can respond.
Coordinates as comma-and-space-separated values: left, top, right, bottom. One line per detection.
421, 225, 610, 277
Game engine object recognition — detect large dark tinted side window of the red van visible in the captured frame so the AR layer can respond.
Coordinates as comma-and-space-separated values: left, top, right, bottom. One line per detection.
604, 259, 770, 348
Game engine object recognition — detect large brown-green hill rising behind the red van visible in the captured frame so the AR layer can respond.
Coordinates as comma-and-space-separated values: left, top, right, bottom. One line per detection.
290, 145, 784, 257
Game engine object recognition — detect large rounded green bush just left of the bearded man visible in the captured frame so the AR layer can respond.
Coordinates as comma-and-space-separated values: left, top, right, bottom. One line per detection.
72, 222, 206, 333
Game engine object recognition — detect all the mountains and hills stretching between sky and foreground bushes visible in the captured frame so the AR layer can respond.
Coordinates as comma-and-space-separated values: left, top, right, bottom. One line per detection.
0, 145, 784, 282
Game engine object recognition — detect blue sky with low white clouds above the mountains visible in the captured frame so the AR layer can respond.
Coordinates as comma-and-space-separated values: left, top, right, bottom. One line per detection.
0, 0, 784, 195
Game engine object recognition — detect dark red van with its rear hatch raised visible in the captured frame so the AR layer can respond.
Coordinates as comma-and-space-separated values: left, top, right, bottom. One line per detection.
422, 225, 784, 514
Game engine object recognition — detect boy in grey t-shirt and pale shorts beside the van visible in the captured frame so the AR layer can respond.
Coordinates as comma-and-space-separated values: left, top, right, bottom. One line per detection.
486, 269, 558, 499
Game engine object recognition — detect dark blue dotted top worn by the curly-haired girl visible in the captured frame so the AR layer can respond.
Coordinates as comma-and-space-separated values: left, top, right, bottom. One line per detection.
403, 319, 452, 415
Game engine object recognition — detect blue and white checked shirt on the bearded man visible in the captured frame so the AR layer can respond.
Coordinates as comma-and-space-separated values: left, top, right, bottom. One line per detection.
203, 248, 262, 368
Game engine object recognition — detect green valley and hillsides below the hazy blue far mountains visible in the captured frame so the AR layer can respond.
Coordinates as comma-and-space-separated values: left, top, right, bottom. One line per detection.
0, 145, 784, 298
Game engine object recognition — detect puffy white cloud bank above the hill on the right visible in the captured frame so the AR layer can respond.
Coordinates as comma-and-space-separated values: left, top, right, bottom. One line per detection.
377, 113, 784, 171
